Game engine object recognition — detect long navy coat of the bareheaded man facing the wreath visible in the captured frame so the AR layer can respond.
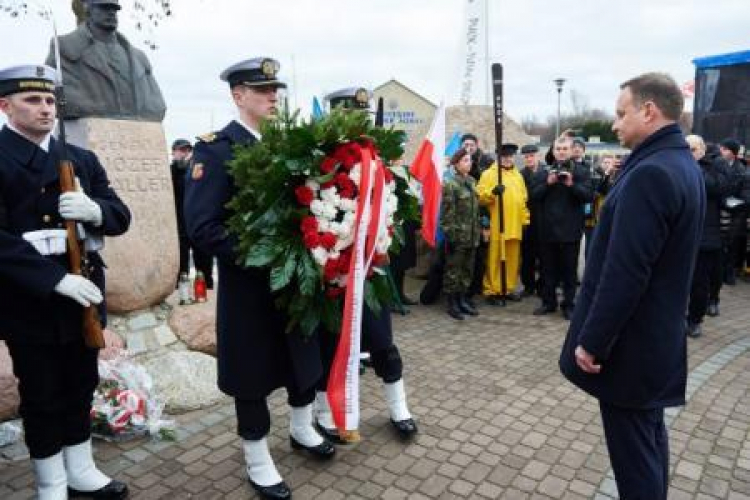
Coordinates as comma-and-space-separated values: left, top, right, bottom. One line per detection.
560, 125, 706, 409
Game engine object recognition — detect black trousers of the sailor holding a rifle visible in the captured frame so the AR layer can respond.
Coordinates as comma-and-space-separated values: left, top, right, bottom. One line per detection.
8, 339, 99, 459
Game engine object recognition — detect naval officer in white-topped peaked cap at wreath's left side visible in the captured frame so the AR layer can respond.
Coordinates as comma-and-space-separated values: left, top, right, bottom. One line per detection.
184, 58, 335, 498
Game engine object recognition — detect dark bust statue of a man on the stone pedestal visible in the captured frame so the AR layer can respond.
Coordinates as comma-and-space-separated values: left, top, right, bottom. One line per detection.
46, 0, 166, 121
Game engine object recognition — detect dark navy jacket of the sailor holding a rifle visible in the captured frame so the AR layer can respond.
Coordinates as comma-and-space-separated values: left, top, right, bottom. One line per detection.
0, 127, 130, 344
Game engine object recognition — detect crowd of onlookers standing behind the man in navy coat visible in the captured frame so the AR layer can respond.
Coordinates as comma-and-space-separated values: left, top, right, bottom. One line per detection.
421, 123, 750, 337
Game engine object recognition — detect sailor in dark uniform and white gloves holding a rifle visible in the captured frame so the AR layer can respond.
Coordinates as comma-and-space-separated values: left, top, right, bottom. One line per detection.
0, 66, 130, 500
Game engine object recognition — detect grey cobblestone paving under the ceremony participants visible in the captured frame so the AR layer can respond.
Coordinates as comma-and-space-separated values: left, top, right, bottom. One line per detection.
0, 283, 750, 500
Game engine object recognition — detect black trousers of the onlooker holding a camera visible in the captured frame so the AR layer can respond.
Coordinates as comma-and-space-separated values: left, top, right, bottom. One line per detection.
540, 242, 580, 309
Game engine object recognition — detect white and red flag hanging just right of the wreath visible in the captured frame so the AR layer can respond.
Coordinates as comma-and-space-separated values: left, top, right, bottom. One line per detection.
409, 103, 445, 247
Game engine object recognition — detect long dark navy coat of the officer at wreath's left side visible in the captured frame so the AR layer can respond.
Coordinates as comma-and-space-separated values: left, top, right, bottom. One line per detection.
183, 121, 322, 399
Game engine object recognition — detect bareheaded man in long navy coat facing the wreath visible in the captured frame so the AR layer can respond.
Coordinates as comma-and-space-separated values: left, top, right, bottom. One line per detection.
560, 73, 706, 499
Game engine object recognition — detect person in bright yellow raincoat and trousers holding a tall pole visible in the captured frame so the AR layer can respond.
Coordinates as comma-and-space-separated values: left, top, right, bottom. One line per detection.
477, 144, 529, 305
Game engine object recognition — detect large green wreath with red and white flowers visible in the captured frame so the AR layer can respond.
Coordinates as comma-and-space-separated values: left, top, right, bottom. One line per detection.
228, 109, 418, 335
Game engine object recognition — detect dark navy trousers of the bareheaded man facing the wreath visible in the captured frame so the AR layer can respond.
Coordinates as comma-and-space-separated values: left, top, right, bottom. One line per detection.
599, 401, 669, 500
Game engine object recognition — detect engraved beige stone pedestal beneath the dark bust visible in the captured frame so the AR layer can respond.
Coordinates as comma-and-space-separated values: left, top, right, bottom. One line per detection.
67, 118, 179, 312
